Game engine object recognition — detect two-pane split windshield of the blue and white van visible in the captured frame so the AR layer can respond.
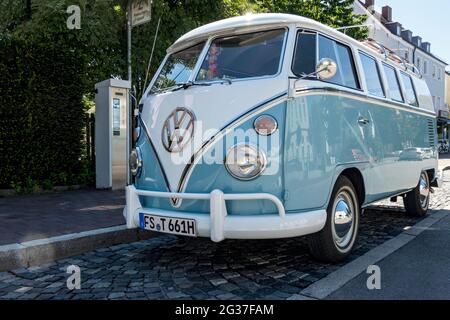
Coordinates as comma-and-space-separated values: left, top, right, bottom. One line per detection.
152, 29, 286, 92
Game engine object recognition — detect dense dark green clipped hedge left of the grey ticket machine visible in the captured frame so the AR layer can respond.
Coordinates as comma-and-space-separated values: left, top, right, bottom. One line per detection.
0, 38, 84, 189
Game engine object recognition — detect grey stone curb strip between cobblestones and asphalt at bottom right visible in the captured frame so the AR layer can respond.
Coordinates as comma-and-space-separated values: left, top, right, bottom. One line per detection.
296, 209, 450, 300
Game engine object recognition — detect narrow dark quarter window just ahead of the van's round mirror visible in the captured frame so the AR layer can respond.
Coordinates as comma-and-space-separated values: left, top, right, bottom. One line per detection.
292, 32, 317, 76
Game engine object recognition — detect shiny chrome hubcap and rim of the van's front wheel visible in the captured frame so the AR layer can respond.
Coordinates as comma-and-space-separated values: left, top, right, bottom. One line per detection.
333, 190, 355, 249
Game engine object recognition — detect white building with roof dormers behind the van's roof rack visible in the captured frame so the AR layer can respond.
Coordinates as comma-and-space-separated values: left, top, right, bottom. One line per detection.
354, 0, 448, 122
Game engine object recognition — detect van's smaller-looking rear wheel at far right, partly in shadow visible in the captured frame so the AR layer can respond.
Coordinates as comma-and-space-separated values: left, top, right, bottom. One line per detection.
403, 171, 431, 217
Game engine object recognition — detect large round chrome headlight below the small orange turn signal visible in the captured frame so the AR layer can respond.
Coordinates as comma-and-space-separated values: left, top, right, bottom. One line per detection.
225, 144, 267, 180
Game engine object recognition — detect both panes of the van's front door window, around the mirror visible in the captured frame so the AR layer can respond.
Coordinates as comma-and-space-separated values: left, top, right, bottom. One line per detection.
292, 31, 360, 89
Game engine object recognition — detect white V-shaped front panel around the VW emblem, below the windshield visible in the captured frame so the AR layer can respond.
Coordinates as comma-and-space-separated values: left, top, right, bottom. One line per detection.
141, 76, 286, 192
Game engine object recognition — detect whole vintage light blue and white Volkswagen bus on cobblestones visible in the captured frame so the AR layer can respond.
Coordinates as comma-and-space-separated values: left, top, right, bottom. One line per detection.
124, 14, 439, 262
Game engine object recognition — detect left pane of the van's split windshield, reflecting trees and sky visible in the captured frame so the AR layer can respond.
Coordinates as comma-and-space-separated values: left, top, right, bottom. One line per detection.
152, 42, 205, 91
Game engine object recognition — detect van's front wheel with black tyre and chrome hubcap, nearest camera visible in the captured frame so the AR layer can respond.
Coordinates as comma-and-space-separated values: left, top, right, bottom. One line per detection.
309, 176, 361, 263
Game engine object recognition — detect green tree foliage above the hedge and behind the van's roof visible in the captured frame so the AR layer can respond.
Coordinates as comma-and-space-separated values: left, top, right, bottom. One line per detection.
0, 0, 367, 98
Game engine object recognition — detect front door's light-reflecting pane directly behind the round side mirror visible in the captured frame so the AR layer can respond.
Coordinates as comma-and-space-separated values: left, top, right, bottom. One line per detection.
319, 36, 360, 89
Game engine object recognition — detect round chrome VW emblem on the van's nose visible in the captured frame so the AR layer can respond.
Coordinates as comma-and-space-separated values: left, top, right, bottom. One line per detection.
161, 108, 195, 152
